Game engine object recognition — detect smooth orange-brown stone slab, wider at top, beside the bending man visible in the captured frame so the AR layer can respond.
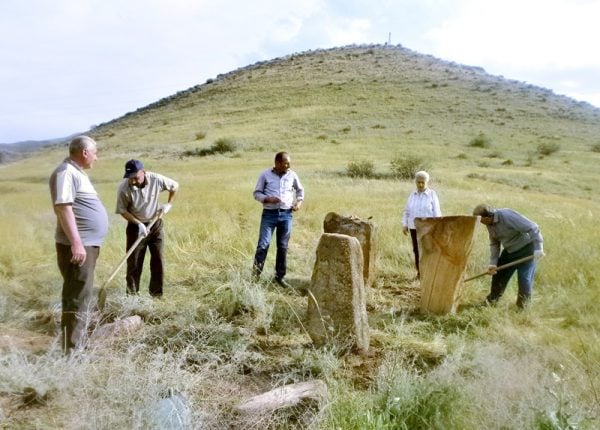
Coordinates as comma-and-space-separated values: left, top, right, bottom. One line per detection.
415, 216, 477, 314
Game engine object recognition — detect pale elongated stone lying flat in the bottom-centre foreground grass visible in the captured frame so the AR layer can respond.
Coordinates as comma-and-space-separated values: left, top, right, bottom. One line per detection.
236, 379, 327, 414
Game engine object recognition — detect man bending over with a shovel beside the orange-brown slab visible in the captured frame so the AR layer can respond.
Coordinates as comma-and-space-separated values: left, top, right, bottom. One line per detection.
473, 204, 545, 309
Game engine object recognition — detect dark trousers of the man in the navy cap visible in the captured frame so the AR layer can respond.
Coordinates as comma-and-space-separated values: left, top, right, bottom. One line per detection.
125, 219, 164, 296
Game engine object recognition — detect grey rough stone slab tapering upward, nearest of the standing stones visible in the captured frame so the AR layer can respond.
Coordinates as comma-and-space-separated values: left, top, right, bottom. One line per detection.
306, 233, 369, 352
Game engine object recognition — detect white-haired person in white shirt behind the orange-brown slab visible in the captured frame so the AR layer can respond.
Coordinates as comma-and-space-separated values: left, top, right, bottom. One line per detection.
402, 170, 442, 279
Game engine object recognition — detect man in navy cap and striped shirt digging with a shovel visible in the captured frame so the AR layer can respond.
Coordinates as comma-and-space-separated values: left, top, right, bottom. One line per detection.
116, 160, 179, 297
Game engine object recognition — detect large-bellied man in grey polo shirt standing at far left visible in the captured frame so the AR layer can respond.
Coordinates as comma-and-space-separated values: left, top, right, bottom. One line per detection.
49, 136, 108, 353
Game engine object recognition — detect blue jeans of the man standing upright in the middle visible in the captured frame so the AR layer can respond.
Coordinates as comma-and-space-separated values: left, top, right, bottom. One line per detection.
253, 209, 292, 279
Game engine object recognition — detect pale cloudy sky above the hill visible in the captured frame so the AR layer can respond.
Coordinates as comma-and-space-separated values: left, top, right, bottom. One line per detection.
0, 0, 600, 143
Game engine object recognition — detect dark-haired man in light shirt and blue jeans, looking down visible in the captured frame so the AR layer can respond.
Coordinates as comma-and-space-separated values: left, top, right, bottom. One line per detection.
253, 152, 304, 287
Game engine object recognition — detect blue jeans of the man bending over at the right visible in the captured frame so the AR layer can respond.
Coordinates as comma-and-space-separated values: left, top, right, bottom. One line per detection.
487, 243, 536, 307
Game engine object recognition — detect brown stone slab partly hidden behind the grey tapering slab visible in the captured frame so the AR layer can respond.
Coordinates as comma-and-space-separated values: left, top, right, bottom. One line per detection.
323, 212, 377, 287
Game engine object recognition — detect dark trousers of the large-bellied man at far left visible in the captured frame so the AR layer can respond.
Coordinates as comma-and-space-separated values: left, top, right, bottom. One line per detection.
56, 243, 100, 353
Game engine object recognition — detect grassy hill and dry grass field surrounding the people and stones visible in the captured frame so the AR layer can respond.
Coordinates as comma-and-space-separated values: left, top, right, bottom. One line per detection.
0, 46, 600, 429
